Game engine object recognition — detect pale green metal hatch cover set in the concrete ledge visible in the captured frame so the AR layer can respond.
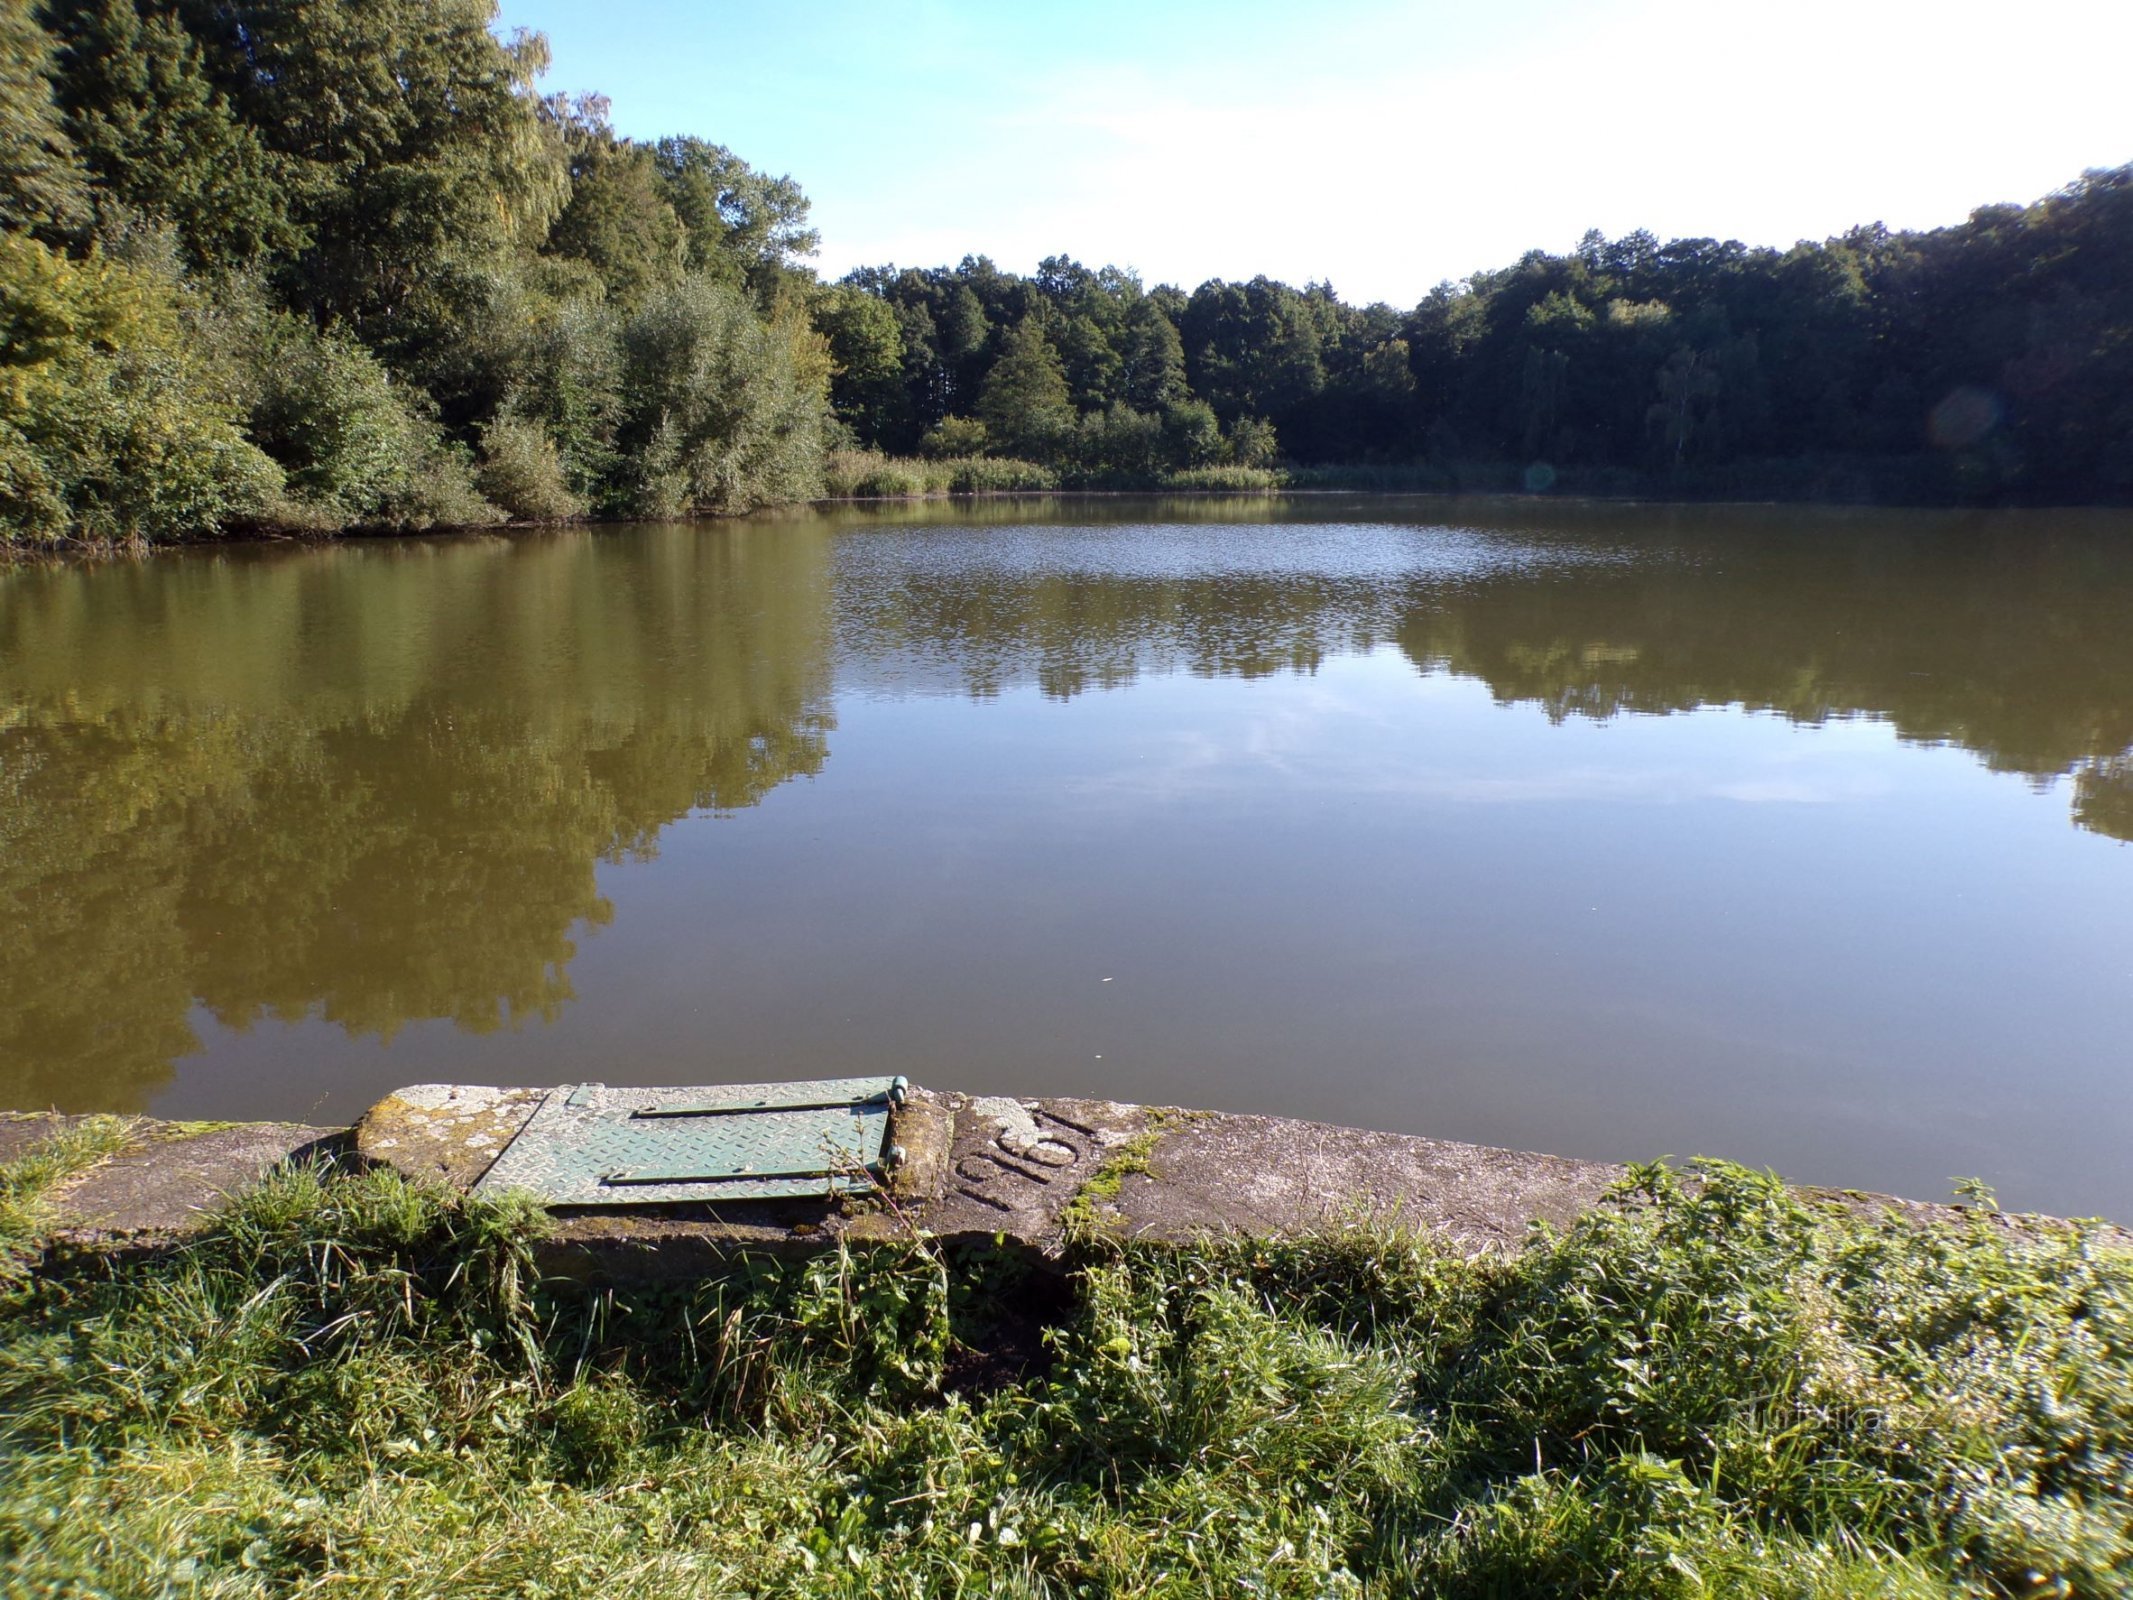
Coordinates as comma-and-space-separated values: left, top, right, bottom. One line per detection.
474, 1077, 904, 1205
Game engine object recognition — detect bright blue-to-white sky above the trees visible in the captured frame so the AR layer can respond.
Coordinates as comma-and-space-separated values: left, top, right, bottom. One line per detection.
499, 0, 2133, 307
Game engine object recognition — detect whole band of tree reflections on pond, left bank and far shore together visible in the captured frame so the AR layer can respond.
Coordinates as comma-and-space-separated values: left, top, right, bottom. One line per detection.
0, 499, 2133, 1134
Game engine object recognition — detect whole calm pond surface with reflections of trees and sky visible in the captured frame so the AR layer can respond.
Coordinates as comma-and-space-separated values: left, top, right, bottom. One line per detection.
12, 497, 2133, 1220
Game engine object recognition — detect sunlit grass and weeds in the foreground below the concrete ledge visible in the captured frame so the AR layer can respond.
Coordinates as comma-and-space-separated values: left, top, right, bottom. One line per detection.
0, 1134, 2133, 1600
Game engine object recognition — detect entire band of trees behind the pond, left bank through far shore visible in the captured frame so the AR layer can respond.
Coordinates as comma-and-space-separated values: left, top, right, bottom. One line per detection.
0, 0, 2133, 542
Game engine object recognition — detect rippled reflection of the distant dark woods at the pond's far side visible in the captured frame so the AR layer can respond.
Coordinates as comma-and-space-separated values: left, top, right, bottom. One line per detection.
836, 501, 2133, 838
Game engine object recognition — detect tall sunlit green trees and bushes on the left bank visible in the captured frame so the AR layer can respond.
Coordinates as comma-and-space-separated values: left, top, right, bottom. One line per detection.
0, 0, 828, 540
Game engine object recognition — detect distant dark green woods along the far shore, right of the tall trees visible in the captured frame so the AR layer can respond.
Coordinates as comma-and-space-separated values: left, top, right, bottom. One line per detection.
819, 166, 2133, 501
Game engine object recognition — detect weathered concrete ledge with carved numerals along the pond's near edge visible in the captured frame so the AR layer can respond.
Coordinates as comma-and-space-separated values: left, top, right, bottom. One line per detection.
12, 1084, 2133, 1282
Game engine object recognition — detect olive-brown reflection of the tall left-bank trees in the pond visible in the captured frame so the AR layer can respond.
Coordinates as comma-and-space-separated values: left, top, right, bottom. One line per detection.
0, 533, 832, 1107
